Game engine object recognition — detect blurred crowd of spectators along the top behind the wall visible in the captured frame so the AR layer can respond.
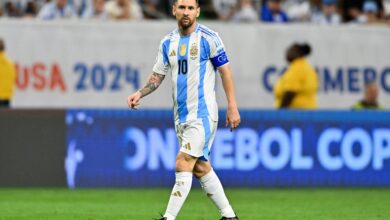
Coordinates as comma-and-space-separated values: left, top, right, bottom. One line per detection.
0, 0, 390, 24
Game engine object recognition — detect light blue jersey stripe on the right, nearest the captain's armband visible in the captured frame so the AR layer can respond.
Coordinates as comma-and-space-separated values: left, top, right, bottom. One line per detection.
197, 37, 210, 118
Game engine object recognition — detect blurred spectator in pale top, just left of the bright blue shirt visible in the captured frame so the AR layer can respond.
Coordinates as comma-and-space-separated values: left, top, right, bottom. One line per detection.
232, 0, 259, 22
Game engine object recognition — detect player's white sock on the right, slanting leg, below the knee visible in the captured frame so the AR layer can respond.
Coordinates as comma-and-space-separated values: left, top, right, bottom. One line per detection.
199, 169, 236, 218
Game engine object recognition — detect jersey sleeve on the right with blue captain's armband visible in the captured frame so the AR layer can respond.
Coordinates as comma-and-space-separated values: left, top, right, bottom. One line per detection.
209, 33, 229, 68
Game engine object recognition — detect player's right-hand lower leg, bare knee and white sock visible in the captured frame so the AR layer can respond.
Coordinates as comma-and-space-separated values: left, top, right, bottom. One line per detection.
193, 160, 236, 218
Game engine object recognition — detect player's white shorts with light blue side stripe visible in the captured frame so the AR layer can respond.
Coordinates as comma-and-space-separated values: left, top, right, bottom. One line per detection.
175, 117, 218, 161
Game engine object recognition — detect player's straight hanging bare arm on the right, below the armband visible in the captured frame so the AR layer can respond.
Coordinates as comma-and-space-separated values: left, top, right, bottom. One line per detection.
218, 64, 241, 131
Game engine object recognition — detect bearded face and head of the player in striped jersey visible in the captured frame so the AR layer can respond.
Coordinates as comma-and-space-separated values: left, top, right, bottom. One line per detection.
172, 0, 200, 29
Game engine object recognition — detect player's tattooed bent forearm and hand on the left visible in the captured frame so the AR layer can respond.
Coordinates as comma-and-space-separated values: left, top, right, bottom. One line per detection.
127, 72, 165, 109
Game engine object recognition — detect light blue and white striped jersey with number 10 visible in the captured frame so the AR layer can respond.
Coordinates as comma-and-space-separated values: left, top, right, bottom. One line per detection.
153, 24, 229, 123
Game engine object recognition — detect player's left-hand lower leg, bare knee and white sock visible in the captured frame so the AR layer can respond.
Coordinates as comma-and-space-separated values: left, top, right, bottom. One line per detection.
164, 152, 198, 220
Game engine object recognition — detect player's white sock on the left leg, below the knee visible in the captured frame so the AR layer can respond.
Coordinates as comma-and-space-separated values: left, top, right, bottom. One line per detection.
164, 172, 192, 220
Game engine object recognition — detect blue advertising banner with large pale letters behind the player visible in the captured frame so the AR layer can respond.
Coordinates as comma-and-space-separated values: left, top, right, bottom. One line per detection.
65, 109, 390, 188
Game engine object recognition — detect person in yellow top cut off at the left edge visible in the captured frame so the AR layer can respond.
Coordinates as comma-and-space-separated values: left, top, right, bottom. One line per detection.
0, 38, 16, 108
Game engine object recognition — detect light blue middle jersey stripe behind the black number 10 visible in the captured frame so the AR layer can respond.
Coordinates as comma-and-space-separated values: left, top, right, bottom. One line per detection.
177, 36, 190, 123
